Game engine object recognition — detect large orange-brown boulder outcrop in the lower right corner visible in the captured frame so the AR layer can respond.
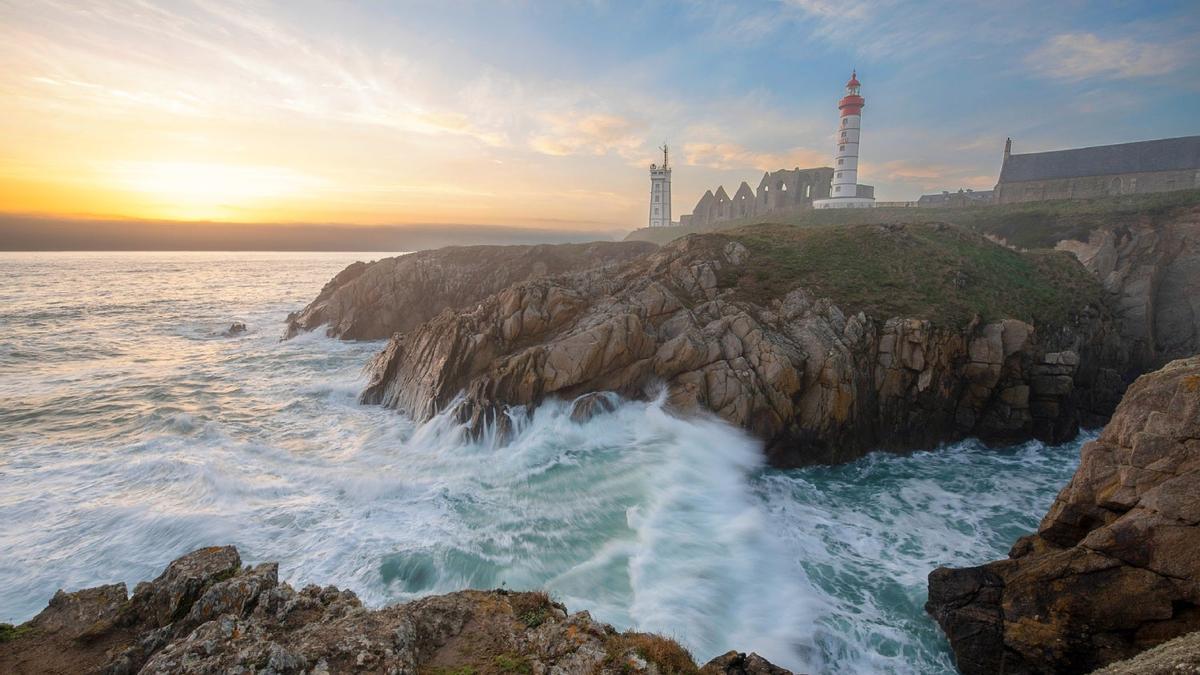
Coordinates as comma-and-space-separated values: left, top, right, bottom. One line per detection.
926, 357, 1200, 675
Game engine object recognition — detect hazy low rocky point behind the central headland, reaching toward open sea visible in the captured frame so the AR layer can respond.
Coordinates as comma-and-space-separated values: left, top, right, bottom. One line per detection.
284, 241, 656, 340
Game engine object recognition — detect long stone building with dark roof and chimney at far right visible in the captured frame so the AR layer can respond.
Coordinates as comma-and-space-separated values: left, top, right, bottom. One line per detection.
994, 136, 1200, 204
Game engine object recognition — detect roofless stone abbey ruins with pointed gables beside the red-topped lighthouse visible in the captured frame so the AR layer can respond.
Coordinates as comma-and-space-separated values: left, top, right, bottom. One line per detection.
679, 167, 833, 226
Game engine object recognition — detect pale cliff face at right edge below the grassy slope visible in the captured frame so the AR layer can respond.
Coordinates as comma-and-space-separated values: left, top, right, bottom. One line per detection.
1057, 208, 1200, 372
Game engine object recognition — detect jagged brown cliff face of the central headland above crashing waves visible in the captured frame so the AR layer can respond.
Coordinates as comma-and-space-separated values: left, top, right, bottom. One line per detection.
362, 234, 1123, 466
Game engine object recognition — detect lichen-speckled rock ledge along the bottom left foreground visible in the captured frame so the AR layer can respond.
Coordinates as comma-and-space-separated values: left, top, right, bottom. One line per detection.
0, 546, 790, 675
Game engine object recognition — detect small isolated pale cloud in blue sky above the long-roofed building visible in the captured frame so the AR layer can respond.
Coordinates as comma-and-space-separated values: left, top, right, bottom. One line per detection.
1026, 32, 1188, 82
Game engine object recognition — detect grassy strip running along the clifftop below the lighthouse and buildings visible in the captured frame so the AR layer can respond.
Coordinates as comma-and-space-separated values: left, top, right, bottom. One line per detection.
626, 190, 1200, 249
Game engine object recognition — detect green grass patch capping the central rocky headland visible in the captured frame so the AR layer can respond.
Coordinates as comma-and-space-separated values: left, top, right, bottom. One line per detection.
721, 223, 1103, 325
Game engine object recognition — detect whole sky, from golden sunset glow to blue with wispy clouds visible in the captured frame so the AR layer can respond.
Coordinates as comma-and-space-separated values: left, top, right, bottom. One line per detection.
0, 0, 1200, 232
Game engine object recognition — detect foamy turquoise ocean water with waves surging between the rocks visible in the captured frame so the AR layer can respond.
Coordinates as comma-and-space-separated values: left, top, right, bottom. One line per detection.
0, 253, 1082, 674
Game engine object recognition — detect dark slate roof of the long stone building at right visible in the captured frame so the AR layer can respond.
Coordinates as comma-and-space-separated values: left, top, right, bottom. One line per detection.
1000, 136, 1200, 183
